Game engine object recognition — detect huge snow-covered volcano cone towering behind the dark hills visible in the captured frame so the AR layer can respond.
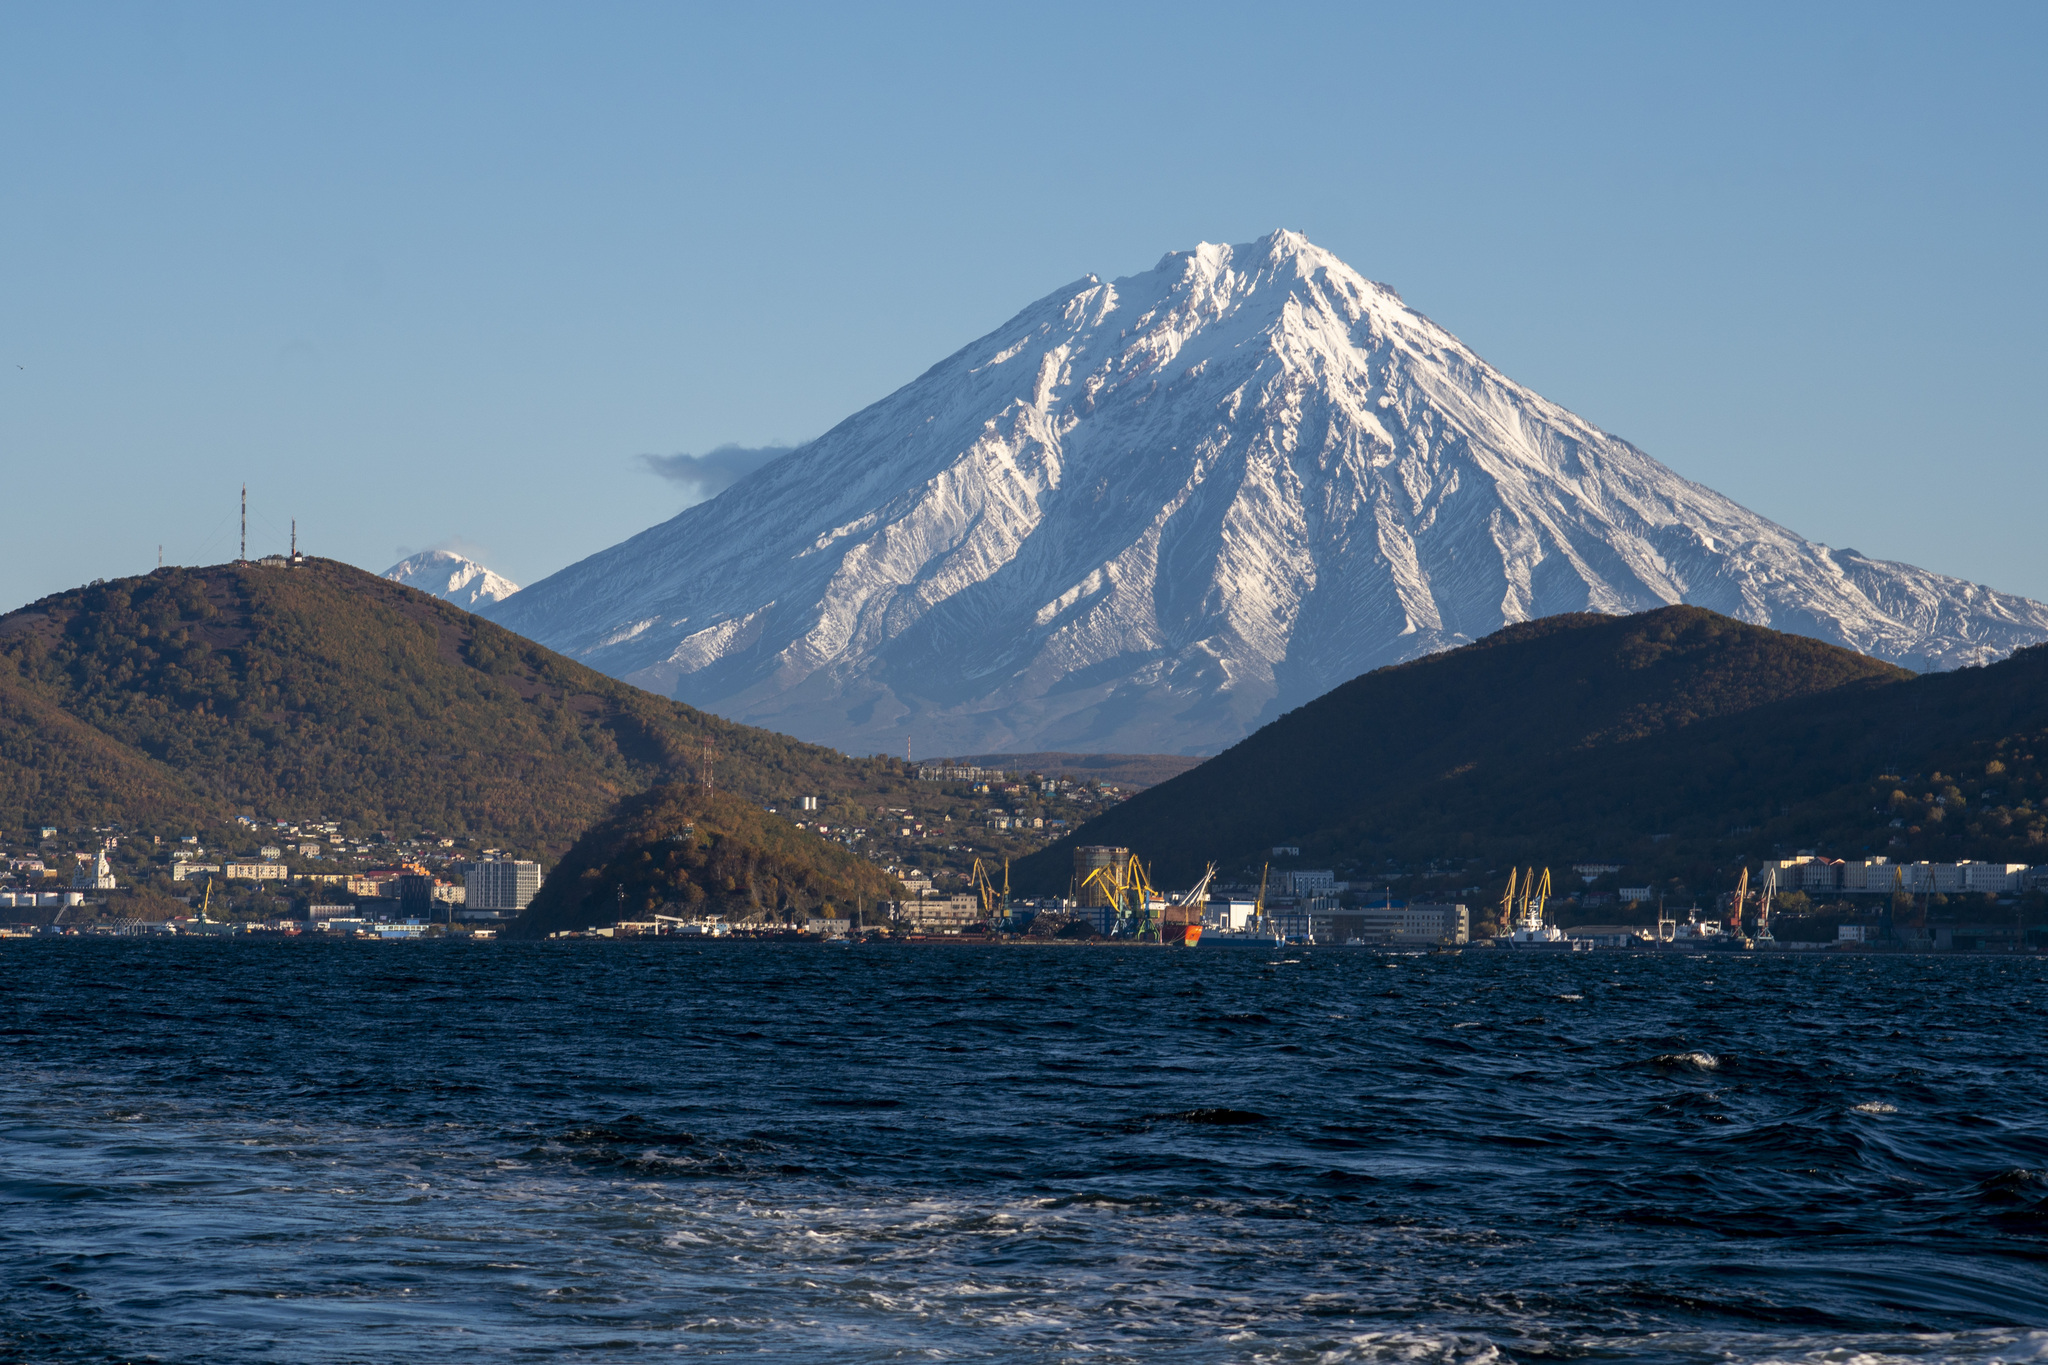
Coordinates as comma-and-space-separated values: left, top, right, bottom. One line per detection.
492, 231, 2048, 753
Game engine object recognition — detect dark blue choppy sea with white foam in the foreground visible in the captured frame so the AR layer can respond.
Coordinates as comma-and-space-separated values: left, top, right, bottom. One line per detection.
0, 941, 2048, 1365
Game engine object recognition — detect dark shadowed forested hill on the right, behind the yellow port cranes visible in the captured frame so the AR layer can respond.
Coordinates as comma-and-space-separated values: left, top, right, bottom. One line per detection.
1012, 606, 2048, 890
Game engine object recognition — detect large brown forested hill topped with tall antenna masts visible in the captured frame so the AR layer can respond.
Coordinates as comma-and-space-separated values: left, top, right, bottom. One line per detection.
0, 559, 950, 855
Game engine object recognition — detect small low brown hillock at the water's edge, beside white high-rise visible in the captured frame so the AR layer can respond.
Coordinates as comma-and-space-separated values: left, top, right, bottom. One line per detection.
508, 784, 901, 937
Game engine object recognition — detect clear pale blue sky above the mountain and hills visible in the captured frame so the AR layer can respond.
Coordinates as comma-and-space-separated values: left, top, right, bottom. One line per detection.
0, 0, 2048, 610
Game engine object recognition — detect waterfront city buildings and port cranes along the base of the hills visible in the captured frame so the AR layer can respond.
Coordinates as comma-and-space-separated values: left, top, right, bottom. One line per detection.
0, 785, 2048, 952
